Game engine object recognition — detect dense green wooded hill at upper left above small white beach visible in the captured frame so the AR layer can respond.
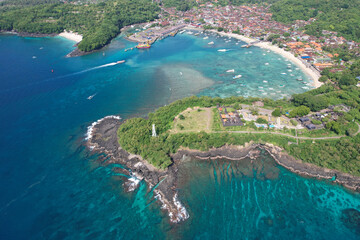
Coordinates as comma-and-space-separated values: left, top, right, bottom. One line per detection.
0, 0, 158, 51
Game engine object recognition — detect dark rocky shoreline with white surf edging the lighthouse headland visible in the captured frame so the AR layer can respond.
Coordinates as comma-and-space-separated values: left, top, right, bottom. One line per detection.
87, 116, 360, 223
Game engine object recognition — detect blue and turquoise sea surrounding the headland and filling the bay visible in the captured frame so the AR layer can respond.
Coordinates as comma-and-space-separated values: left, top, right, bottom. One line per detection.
0, 31, 360, 239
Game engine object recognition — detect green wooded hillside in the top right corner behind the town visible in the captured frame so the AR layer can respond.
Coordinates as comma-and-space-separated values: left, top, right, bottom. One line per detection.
271, 0, 360, 41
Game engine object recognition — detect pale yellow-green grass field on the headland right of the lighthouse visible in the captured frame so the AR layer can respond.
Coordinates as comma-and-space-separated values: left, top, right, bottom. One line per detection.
170, 107, 213, 133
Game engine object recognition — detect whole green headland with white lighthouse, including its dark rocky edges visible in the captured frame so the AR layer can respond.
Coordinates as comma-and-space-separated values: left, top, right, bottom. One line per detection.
88, 78, 360, 223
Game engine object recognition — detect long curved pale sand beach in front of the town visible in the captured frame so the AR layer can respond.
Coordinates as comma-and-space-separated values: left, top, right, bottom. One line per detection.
185, 26, 323, 88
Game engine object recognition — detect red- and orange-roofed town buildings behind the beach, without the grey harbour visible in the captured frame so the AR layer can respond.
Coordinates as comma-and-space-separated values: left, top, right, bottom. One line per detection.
160, 3, 360, 72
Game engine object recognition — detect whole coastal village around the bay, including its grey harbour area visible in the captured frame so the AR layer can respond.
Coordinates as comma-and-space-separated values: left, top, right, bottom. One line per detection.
128, 3, 360, 79
